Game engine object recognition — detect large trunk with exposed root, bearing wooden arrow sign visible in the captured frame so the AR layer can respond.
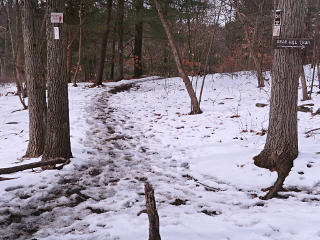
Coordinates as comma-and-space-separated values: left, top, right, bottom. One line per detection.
254, 0, 305, 199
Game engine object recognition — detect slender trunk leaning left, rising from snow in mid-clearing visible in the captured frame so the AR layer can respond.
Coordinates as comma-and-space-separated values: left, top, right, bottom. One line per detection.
153, 0, 201, 114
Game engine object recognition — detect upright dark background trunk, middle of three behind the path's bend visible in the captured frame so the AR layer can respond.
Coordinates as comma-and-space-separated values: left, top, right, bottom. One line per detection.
116, 0, 124, 81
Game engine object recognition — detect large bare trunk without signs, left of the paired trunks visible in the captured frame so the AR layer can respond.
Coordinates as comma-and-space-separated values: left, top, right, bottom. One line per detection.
23, 0, 46, 157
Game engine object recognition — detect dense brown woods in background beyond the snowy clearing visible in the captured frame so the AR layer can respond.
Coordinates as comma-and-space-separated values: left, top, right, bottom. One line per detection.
0, 0, 318, 85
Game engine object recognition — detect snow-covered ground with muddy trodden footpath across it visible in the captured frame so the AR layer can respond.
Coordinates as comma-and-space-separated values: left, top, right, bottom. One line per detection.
0, 67, 320, 240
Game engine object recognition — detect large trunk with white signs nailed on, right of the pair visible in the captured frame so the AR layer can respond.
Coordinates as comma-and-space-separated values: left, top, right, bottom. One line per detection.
43, 0, 72, 160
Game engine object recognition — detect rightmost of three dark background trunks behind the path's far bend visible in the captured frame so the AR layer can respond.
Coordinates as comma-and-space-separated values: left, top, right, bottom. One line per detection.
134, 0, 143, 78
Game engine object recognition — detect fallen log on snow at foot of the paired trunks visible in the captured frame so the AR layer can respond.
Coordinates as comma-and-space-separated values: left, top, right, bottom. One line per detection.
0, 158, 69, 175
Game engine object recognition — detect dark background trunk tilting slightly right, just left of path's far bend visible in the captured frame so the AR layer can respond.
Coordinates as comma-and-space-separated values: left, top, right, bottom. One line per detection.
96, 0, 112, 85
